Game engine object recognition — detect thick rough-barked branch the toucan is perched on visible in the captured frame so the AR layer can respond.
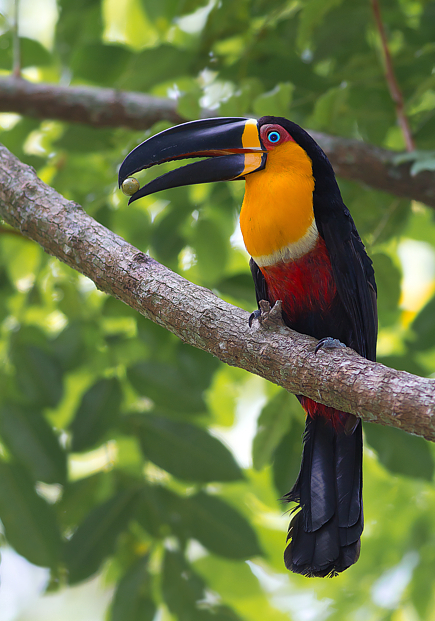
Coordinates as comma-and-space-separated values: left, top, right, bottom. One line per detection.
0, 140, 435, 440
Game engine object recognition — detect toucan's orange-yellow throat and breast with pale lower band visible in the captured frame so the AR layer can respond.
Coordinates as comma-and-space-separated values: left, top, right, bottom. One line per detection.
240, 142, 318, 267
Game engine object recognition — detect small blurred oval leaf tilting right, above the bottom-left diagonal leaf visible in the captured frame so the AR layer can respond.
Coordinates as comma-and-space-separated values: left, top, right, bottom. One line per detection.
70, 377, 122, 452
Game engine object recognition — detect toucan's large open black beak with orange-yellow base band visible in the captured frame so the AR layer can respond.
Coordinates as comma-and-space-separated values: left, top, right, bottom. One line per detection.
118, 117, 267, 204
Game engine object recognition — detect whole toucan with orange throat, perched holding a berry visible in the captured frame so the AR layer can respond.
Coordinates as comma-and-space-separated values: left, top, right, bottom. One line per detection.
119, 116, 377, 577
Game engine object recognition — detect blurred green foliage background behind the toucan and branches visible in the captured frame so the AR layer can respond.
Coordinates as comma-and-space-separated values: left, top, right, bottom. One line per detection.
0, 0, 435, 621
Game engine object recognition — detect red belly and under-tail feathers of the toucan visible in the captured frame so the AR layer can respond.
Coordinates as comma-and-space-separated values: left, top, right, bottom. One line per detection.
260, 237, 348, 427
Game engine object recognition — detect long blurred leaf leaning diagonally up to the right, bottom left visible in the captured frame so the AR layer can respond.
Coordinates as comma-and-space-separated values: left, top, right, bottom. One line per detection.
65, 489, 137, 584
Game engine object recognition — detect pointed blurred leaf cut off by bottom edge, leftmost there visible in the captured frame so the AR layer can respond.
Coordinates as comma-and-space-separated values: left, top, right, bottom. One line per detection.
110, 555, 156, 621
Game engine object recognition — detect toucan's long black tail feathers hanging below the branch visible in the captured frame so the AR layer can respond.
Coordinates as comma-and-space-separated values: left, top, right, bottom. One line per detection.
284, 416, 363, 577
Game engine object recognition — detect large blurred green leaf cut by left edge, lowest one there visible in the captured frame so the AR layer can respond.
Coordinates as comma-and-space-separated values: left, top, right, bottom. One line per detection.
0, 461, 61, 568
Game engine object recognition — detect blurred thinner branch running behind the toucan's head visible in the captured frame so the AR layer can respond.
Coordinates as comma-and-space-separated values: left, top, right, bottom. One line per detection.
0, 77, 435, 207
